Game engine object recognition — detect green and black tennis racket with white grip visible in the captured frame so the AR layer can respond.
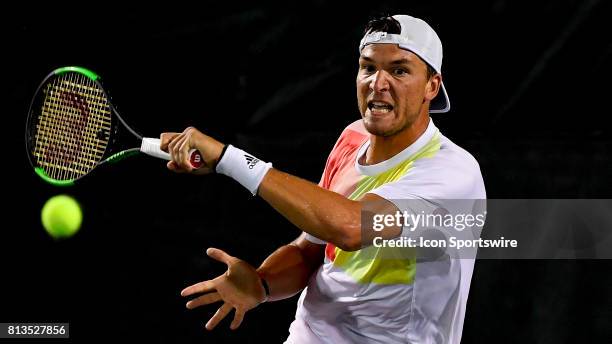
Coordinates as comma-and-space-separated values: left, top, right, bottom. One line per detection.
26, 67, 204, 186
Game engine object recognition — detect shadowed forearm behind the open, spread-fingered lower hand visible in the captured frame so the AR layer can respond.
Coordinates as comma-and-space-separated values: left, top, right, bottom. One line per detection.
257, 244, 322, 301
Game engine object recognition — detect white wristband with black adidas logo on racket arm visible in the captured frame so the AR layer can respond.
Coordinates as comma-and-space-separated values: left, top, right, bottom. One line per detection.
216, 145, 272, 196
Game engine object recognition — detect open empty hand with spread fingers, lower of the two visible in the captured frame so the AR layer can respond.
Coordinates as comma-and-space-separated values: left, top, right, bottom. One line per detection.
181, 248, 266, 330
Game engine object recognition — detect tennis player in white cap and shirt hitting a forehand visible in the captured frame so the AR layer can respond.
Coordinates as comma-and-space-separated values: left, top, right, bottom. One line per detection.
161, 15, 486, 344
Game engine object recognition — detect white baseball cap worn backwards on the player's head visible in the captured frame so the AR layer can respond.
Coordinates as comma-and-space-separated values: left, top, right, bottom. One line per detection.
359, 14, 450, 113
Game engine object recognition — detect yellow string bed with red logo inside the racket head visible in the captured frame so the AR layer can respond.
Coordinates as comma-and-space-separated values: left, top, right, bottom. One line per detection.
34, 73, 111, 180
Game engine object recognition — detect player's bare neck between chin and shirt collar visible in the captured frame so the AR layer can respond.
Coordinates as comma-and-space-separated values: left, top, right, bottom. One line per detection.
363, 114, 429, 165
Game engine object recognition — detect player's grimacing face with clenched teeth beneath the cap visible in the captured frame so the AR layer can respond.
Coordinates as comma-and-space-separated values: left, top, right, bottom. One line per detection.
357, 44, 440, 137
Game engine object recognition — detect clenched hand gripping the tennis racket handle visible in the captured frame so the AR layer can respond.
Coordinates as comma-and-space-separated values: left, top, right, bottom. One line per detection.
160, 127, 224, 174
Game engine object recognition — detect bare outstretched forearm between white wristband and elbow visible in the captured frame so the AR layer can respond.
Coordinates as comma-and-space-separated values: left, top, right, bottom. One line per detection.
258, 169, 361, 250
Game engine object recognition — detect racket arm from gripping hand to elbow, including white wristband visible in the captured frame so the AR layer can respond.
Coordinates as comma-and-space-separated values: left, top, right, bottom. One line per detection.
170, 133, 392, 251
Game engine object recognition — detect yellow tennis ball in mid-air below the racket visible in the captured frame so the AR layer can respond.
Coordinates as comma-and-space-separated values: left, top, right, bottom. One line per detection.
41, 195, 83, 239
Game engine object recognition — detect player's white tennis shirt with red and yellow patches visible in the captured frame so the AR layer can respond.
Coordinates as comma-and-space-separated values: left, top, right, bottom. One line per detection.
286, 120, 486, 344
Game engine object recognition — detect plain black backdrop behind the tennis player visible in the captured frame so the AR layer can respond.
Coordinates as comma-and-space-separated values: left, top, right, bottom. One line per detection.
0, 0, 612, 343
